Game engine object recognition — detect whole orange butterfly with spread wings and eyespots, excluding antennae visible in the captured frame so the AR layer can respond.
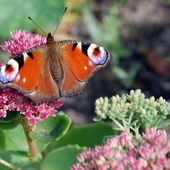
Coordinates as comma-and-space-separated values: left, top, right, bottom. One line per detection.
0, 34, 111, 104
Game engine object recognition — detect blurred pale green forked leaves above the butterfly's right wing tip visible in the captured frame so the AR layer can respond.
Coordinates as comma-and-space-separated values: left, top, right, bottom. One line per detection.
82, 5, 131, 60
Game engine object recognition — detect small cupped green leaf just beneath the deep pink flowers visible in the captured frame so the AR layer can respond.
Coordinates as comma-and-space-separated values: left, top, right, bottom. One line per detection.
29, 113, 71, 143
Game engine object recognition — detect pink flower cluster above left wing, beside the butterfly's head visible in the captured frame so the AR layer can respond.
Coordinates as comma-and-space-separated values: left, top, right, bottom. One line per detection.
1, 30, 47, 54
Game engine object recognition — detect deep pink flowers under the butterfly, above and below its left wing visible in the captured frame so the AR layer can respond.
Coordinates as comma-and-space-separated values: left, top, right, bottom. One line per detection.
0, 30, 62, 125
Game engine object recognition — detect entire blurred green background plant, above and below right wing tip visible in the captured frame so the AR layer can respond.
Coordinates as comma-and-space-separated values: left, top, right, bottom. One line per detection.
83, 2, 140, 88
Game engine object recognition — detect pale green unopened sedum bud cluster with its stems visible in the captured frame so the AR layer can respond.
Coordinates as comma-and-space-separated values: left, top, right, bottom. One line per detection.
95, 90, 170, 137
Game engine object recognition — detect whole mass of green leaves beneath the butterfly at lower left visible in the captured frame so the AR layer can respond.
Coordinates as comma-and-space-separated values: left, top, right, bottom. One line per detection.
0, 113, 115, 170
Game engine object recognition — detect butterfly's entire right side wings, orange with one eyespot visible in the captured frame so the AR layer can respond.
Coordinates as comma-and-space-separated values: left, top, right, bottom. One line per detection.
58, 41, 111, 96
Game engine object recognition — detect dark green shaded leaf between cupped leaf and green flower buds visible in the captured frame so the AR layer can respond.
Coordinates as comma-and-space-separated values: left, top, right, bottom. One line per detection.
53, 122, 116, 147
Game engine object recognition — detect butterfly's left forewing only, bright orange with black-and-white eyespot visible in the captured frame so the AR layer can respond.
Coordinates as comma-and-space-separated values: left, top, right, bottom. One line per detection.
0, 51, 44, 93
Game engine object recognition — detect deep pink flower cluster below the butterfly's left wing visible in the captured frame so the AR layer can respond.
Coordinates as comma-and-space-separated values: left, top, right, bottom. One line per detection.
0, 88, 62, 125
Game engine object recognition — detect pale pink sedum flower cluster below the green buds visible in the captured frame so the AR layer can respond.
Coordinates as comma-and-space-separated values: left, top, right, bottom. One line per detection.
71, 127, 170, 170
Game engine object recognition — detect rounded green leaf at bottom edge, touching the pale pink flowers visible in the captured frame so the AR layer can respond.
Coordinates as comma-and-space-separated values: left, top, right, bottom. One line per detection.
41, 146, 83, 170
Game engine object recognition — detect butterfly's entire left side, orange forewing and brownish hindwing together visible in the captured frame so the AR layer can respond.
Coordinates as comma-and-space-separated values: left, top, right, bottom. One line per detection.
0, 47, 59, 104
